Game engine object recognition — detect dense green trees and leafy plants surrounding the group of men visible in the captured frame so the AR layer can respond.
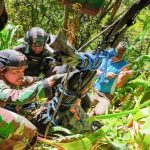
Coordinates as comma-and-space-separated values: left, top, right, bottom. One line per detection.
0, 0, 150, 150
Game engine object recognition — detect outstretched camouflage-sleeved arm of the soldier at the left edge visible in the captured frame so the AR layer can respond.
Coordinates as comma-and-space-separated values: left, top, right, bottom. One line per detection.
0, 77, 55, 105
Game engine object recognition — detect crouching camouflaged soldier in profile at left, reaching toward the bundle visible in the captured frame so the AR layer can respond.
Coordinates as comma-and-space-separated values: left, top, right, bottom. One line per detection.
0, 50, 61, 149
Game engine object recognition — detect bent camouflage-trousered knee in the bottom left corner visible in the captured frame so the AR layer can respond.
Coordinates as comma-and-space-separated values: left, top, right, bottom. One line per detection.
0, 108, 37, 150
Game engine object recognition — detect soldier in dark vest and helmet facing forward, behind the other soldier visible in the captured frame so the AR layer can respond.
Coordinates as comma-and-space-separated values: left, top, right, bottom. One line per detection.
14, 27, 54, 77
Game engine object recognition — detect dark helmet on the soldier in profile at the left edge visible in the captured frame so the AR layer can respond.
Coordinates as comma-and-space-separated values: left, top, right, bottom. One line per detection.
0, 50, 27, 69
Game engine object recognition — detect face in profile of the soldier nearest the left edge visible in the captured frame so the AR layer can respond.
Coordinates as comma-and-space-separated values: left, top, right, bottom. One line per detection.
4, 66, 26, 86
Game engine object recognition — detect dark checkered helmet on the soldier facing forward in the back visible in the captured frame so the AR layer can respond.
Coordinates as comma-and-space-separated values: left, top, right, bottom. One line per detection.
25, 27, 48, 46
